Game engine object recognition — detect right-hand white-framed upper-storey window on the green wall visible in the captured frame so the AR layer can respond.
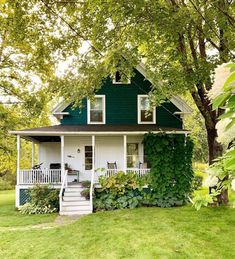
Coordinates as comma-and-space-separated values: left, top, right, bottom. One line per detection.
137, 95, 156, 124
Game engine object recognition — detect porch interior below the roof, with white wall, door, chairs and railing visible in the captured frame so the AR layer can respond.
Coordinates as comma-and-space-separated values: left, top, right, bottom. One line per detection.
17, 135, 150, 185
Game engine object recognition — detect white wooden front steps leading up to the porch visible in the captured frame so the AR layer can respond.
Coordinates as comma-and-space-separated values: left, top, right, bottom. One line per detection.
60, 184, 92, 216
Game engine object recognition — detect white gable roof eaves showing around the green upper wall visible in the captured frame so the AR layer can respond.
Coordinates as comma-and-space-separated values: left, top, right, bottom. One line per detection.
52, 63, 193, 118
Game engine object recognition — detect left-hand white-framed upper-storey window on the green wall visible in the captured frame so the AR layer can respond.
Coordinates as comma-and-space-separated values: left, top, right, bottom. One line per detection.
87, 95, 106, 124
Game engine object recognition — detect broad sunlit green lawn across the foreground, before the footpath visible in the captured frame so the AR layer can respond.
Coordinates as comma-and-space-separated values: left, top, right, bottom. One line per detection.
0, 192, 235, 259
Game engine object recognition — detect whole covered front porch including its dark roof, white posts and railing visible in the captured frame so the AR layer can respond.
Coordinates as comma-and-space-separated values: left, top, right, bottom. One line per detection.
12, 125, 188, 208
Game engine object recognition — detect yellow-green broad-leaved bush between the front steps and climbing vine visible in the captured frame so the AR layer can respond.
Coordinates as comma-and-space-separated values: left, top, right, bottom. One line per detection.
94, 172, 146, 211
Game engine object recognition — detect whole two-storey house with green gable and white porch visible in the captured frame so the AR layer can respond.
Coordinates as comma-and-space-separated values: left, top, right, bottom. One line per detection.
11, 65, 192, 215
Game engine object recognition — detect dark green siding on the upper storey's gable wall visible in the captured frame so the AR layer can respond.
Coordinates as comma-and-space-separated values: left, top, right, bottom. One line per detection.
61, 71, 182, 128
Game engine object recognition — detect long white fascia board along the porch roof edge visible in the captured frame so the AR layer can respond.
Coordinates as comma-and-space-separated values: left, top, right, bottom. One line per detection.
10, 130, 190, 136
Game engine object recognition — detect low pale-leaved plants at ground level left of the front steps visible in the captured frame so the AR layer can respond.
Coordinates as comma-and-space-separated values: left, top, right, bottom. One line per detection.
19, 202, 57, 214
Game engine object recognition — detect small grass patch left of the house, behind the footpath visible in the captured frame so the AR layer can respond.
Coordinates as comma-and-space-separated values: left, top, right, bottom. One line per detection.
0, 190, 57, 227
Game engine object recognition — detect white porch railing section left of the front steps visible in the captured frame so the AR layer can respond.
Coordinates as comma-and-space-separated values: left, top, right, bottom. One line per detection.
18, 169, 61, 184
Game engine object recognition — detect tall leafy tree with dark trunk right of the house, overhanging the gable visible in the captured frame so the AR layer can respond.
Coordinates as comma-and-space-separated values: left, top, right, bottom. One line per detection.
41, 0, 235, 171
